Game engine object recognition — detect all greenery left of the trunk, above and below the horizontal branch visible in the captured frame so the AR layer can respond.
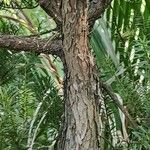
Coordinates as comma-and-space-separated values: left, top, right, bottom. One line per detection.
0, 0, 63, 150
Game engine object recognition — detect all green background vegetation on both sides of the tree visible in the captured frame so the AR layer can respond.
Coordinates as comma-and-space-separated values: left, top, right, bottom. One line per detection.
0, 0, 150, 150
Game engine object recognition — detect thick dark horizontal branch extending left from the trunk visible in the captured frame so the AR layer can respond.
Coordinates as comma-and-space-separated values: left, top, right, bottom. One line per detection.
0, 35, 63, 58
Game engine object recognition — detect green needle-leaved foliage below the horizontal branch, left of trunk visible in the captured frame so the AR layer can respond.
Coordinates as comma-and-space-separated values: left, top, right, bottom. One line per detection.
0, 50, 63, 150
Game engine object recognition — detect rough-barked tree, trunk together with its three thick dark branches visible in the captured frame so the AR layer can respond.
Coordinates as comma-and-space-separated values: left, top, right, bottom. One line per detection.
0, 0, 112, 150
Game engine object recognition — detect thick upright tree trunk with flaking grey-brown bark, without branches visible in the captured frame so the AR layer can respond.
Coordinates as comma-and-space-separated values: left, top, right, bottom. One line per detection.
57, 0, 101, 150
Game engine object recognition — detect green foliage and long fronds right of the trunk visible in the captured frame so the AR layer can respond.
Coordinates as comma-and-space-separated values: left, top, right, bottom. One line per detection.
91, 0, 150, 149
